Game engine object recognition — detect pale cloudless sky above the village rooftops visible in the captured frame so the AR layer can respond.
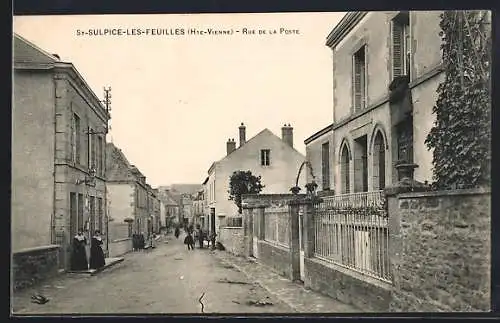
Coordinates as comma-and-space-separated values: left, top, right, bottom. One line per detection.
13, 13, 344, 186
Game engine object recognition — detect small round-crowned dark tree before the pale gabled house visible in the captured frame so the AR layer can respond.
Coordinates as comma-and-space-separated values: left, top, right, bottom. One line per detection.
228, 170, 265, 214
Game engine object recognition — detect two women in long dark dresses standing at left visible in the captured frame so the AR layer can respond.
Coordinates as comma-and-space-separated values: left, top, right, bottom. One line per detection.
71, 230, 105, 271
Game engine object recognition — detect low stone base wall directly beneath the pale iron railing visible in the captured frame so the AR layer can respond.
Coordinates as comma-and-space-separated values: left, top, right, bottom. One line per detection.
304, 258, 391, 312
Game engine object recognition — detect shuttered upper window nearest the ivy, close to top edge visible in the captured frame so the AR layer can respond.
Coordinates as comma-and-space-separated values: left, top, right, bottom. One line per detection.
391, 12, 411, 79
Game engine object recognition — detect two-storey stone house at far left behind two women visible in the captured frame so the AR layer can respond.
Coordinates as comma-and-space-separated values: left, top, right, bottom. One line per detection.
11, 34, 110, 268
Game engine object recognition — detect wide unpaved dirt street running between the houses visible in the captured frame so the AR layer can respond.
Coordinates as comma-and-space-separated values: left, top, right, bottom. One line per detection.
13, 234, 358, 314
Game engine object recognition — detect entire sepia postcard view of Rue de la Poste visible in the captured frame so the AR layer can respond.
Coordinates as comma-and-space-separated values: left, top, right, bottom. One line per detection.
10, 10, 493, 317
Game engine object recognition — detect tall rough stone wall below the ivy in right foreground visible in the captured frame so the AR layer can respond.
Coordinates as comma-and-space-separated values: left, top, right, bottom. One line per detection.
389, 190, 491, 312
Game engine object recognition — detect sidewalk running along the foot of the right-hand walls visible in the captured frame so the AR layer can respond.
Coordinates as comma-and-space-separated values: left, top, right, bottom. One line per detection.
213, 251, 363, 313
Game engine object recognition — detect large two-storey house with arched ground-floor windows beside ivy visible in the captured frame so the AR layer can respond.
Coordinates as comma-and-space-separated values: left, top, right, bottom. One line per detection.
305, 11, 443, 194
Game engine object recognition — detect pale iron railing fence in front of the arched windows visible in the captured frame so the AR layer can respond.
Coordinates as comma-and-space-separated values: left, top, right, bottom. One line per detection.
314, 191, 392, 282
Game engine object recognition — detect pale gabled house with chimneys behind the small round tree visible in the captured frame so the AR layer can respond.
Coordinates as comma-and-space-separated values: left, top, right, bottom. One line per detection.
205, 124, 306, 251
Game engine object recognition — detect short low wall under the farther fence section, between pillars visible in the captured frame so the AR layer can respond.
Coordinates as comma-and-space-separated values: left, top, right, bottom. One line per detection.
257, 240, 292, 279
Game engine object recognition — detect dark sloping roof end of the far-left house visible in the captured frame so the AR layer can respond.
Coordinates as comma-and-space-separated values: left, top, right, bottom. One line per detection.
12, 34, 60, 64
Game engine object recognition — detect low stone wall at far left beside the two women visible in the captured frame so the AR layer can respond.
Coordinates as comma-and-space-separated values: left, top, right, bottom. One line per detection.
12, 245, 60, 290
